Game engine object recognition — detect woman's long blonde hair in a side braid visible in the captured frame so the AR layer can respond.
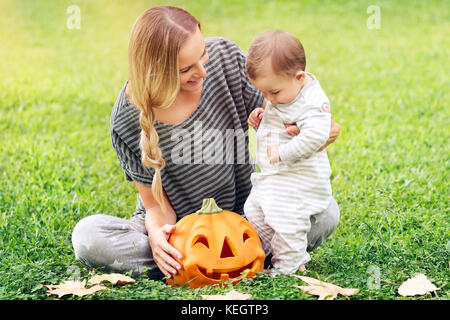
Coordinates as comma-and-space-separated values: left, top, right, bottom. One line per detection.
128, 6, 200, 209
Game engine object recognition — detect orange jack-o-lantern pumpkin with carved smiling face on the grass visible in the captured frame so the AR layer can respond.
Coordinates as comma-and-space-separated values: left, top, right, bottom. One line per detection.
167, 198, 265, 288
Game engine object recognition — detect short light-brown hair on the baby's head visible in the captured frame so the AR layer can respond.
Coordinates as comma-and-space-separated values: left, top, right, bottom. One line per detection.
245, 30, 306, 79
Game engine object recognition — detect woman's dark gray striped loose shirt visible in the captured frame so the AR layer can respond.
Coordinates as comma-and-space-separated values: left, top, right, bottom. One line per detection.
111, 37, 263, 219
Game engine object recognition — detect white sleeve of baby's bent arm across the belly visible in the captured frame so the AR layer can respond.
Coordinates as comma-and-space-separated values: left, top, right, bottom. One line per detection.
278, 105, 331, 162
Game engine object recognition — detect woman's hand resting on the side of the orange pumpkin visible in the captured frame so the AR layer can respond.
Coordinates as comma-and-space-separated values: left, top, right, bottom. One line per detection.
148, 224, 183, 277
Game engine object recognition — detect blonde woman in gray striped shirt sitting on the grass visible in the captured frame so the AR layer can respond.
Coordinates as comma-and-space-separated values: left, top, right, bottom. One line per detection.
72, 6, 339, 277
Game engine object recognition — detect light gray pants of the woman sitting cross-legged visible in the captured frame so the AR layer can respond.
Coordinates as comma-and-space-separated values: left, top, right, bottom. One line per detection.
72, 199, 340, 278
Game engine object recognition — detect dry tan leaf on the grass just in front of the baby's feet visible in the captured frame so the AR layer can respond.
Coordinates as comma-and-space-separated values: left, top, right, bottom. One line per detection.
293, 274, 358, 300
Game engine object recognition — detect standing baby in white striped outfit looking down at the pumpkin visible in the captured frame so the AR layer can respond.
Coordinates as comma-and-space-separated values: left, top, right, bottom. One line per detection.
244, 30, 334, 274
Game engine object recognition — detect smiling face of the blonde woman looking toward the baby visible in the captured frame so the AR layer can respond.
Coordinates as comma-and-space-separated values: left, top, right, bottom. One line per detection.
178, 28, 209, 92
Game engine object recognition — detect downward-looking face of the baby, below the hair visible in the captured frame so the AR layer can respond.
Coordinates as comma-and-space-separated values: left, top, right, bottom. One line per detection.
250, 71, 301, 104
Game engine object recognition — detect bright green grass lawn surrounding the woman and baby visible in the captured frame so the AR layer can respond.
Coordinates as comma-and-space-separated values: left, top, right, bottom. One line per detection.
0, 0, 450, 299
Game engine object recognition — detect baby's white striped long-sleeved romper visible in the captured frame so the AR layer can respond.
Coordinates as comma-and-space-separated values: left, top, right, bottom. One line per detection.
244, 73, 332, 273
